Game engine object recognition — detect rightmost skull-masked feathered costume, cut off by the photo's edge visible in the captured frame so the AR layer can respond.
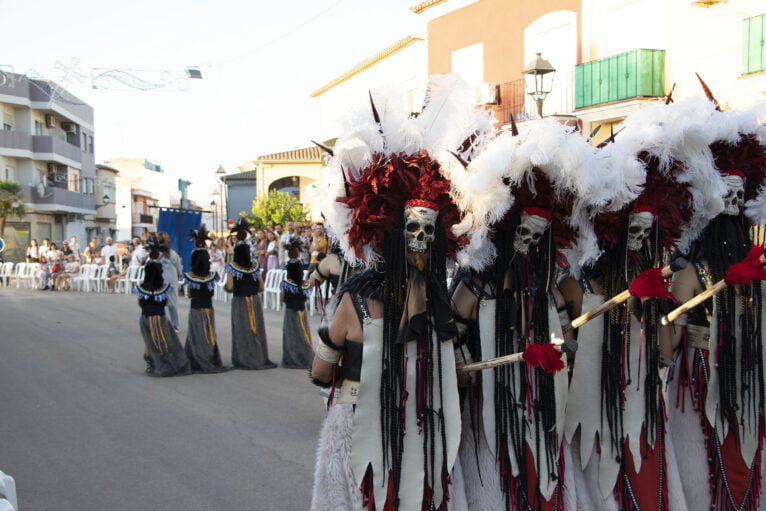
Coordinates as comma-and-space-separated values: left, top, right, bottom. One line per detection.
667, 98, 766, 510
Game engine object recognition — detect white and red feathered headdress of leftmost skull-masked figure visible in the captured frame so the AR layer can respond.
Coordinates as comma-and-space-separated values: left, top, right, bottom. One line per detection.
323, 75, 491, 264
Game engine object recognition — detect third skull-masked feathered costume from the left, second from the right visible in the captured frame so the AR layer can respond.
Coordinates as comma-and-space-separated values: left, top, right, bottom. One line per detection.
566, 97, 732, 510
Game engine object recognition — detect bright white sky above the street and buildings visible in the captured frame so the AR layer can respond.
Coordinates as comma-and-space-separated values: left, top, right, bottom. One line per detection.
0, 0, 423, 205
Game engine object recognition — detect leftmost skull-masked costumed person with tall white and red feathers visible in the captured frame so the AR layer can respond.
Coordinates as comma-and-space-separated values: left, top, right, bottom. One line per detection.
312, 76, 492, 511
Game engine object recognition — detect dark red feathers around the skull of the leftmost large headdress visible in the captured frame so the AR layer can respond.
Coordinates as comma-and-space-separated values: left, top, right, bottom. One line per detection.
337, 151, 468, 258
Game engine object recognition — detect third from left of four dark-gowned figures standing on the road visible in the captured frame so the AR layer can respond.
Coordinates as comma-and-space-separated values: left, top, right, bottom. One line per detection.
226, 218, 277, 369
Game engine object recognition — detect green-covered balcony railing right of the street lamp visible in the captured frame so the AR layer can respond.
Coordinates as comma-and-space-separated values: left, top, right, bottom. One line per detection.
575, 49, 665, 109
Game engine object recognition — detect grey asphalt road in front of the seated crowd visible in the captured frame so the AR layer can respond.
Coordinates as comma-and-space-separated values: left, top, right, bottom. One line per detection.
0, 287, 324, 511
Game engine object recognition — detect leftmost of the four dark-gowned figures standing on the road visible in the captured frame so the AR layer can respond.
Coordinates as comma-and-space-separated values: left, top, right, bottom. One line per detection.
133, 240, 191, 376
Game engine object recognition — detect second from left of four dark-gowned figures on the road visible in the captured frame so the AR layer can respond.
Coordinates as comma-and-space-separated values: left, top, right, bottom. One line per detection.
184, 224, 223, 373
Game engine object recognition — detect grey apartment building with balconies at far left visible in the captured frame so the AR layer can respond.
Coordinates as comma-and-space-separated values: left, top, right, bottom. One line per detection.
0, 73, 108, 260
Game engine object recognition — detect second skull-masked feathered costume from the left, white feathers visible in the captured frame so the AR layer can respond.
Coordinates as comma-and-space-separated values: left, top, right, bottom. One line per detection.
453, 122, 624, 511
